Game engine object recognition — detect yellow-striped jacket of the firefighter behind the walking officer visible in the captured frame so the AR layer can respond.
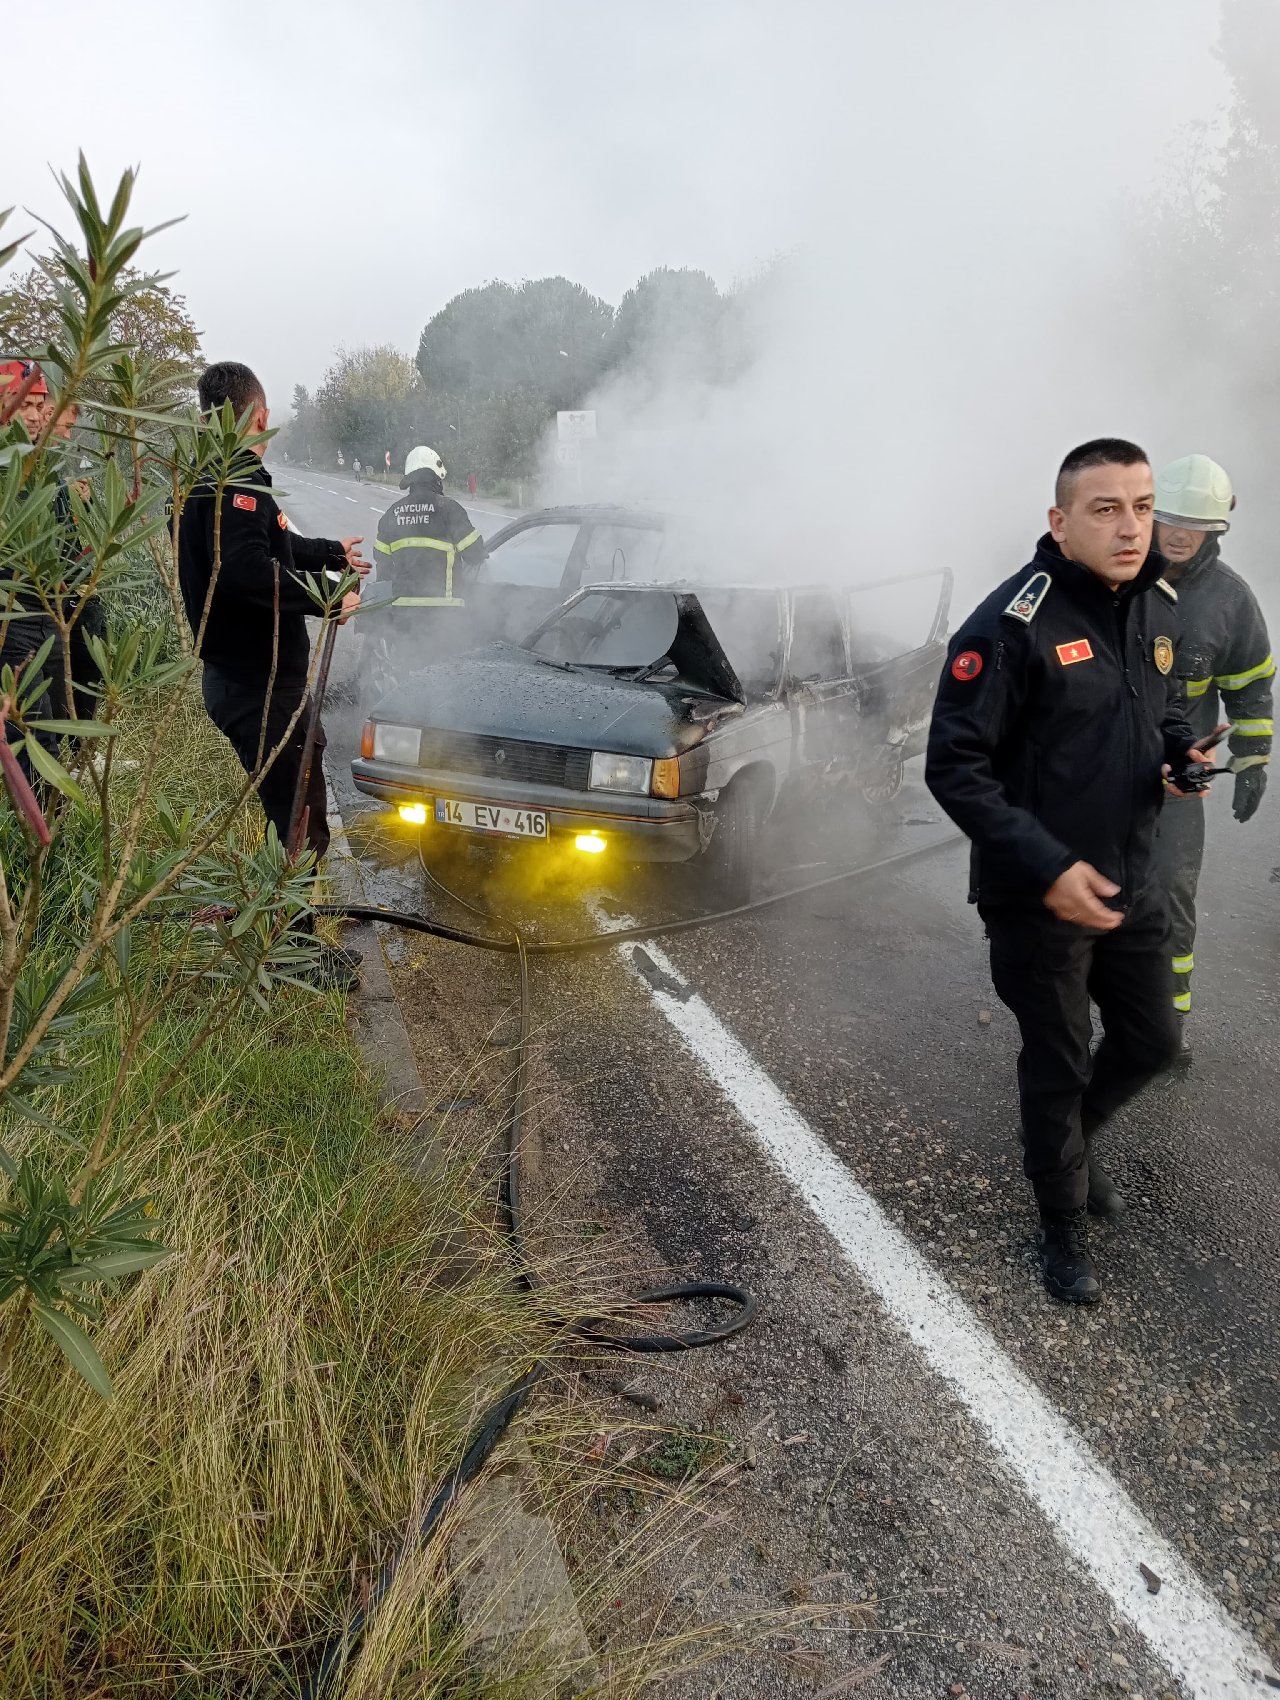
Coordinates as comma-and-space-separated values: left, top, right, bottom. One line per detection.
1166, 537, 1275, 765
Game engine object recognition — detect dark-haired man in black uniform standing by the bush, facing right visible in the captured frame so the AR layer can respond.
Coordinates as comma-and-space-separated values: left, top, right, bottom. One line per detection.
178, 360, 369, 989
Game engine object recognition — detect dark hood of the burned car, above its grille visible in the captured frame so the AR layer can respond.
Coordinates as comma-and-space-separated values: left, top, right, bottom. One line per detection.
374, 643, 738, 757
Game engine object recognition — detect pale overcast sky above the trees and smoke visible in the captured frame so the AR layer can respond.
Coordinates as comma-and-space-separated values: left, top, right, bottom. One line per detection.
5, 0, 1224, 410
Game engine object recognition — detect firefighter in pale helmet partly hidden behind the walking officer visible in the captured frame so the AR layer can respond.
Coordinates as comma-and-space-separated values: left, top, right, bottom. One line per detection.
1156, 454, 1275, 1064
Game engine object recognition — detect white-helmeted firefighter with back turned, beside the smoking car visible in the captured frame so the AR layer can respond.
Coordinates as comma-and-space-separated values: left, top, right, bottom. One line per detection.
374, 444, 486, 672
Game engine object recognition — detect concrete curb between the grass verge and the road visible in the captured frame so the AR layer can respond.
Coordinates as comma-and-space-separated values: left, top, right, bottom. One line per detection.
325, 785, 602, 1697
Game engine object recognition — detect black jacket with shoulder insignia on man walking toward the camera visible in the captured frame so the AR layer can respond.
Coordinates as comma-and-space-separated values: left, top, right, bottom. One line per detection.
925, 537, 1195, 908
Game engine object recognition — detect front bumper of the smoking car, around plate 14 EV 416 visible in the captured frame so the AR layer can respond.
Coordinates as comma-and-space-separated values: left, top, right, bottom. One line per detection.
352, 757, 702, 862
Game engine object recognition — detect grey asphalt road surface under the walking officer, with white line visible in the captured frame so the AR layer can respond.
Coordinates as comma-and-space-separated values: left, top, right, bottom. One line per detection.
280, 474, 1280, 1700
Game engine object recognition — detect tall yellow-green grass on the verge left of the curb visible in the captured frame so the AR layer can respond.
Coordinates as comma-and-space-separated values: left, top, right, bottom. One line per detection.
0, 692, 537, 1700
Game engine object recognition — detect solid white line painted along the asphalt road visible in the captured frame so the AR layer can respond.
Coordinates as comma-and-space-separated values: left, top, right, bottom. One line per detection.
597, 911, 1272, 1700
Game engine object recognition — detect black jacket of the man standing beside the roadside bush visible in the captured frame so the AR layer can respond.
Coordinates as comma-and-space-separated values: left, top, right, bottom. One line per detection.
178, 457, 347, 690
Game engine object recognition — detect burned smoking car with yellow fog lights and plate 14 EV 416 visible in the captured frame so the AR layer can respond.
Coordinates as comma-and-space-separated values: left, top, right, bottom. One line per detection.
352, 570, 950, 903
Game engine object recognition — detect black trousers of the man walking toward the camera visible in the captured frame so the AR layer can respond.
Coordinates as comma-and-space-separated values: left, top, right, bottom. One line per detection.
981, 882, 1180, 1212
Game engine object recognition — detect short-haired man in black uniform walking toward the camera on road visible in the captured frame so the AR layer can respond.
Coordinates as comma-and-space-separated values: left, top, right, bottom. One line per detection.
925, 439, 1212, 1304
